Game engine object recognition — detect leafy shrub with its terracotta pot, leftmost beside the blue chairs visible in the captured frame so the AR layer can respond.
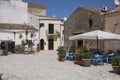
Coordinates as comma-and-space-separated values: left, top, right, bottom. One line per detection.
57, 46, 66, 61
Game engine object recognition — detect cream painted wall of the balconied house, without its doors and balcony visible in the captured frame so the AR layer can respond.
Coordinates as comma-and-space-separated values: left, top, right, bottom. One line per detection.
40, 19, 61, 50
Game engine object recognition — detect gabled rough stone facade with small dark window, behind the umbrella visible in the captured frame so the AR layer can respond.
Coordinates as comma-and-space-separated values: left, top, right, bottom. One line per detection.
64, 7, 103, 48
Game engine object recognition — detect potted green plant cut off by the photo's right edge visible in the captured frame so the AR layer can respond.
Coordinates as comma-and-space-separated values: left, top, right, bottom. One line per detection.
111, 56, 120, 73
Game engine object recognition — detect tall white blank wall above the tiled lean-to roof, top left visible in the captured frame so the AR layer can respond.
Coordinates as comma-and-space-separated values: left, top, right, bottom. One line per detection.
0, 0, 28, 24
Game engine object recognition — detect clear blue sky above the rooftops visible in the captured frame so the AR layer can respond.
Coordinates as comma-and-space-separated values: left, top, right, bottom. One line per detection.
24, 0, 120, 18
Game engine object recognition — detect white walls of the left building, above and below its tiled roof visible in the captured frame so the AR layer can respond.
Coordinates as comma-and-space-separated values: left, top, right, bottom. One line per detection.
0, 0, 39, 49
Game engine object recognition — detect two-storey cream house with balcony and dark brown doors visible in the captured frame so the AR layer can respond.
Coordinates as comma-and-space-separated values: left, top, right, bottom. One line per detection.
39, 16, 64, 50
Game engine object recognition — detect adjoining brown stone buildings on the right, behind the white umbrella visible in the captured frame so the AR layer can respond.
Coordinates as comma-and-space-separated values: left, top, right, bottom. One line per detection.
64, 6, 120, 50
